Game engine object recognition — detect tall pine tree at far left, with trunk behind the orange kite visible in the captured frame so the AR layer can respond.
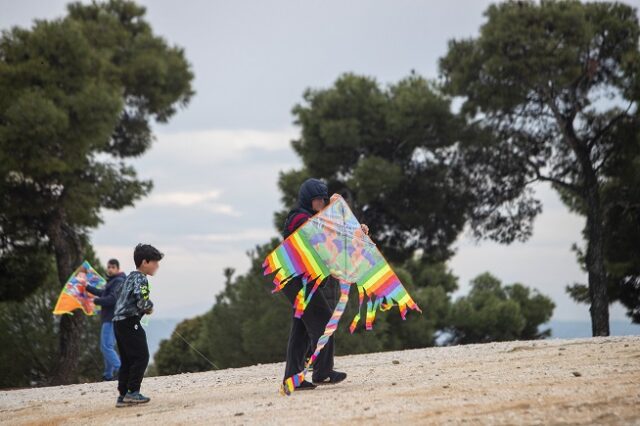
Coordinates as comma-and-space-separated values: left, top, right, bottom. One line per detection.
0, 0, 193, 384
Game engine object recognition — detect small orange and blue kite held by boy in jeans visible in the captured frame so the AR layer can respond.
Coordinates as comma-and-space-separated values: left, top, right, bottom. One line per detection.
53, 260, 106, 315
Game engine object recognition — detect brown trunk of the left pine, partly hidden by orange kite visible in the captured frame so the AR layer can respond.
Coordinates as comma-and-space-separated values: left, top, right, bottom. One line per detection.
47, 213, 84, 385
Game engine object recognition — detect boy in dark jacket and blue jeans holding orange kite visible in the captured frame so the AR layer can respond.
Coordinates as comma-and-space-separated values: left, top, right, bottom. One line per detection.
86, 259, 126, 382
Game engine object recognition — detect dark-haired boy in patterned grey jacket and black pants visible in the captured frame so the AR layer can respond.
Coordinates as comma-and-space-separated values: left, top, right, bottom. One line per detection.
113, 244, 164, 407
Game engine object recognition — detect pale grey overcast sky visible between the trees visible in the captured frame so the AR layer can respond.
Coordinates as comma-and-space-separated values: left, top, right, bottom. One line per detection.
0, 0, 640, 320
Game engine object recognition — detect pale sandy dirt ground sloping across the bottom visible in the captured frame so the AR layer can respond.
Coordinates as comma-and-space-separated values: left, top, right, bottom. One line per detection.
0, 336, 640, 425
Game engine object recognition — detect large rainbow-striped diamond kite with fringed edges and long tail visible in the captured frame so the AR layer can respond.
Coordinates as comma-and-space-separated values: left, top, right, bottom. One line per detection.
262, 194, 422, 395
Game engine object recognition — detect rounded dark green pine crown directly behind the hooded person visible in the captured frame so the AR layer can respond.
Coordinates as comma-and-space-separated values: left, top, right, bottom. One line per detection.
276, 74, 468, 263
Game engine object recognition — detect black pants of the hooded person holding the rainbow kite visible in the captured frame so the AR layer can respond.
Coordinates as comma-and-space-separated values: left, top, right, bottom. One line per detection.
284, 282, 334, 380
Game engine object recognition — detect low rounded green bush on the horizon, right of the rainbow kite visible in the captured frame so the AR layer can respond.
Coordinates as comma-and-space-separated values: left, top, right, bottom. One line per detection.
447, 272, 555, 344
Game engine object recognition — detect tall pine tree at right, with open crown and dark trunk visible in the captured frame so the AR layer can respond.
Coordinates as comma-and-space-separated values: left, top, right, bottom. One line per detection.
440, 1, 640, 335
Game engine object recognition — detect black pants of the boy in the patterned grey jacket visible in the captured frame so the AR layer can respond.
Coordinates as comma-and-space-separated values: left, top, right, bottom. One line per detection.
113, 317, 149, 395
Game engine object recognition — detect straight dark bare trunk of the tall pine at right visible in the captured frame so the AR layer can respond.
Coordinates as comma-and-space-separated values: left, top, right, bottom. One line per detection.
586, 185, 609, 336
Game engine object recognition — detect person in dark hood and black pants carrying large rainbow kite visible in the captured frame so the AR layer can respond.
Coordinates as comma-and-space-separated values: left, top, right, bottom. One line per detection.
282, 179, 369, 390
